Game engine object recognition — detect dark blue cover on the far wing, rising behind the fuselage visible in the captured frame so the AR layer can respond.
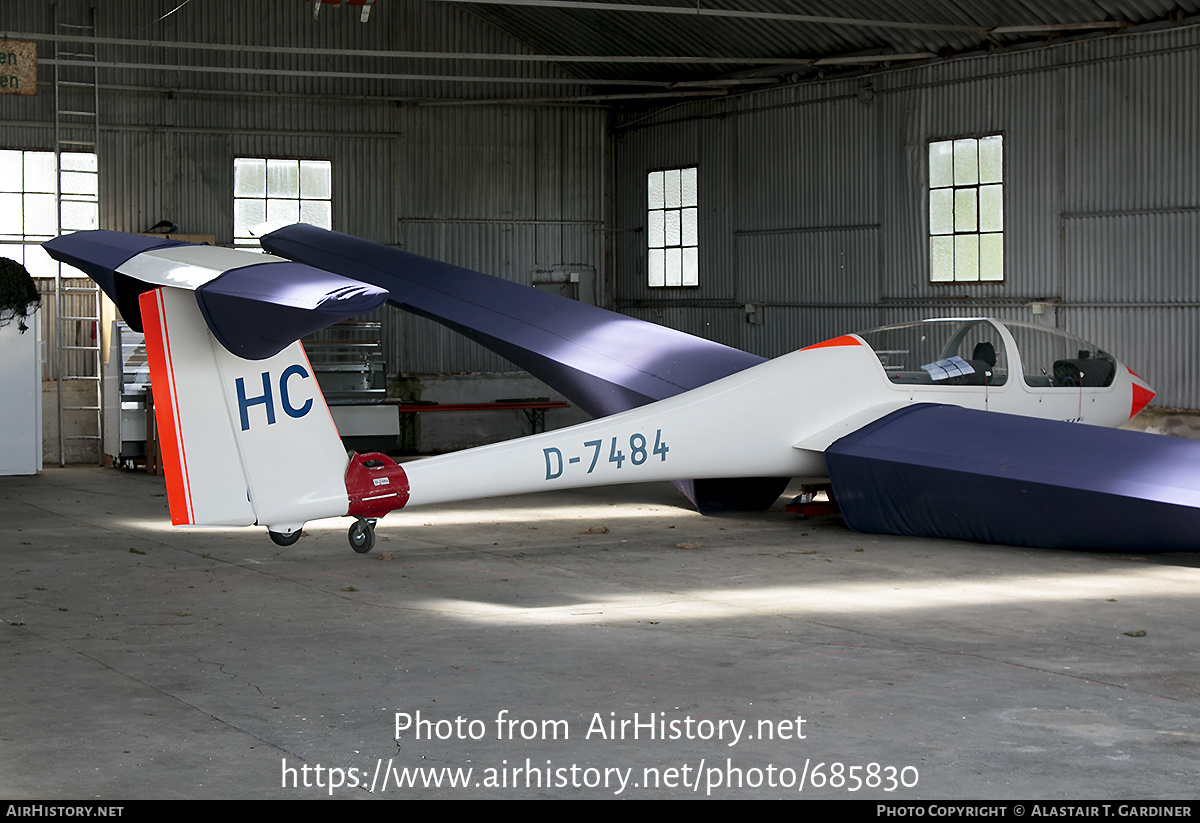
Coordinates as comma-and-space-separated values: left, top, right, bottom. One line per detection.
262, 224, 763, 416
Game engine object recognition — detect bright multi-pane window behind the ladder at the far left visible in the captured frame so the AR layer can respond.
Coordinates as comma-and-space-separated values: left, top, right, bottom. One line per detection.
0, 150, 100, 277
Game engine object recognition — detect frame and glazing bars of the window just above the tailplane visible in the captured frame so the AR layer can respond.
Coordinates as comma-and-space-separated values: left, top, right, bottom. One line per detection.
233, 156, 334, 250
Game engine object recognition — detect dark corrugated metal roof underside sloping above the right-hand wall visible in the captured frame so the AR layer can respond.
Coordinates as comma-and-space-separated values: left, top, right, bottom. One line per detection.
444, 0, 1200, 89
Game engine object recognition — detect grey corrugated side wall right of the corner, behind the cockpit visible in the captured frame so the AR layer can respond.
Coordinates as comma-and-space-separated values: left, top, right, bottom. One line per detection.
613, 28, 1200, 408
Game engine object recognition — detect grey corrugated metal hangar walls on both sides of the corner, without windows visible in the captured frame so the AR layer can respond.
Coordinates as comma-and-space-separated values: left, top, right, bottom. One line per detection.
9, 0, 1200, 408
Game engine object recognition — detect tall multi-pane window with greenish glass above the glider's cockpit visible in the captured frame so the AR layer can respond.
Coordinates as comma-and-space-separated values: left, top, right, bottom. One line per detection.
929, 134, 1004, 283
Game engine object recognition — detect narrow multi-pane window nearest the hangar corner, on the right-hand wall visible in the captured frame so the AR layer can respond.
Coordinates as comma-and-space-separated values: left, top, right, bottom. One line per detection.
646, 167, 700, 288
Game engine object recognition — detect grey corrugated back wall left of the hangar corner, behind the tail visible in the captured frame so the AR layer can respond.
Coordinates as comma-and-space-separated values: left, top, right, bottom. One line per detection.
0, 0, 607, 373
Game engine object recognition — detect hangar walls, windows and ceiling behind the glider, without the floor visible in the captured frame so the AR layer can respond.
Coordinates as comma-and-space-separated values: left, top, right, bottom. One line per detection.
0, 0, 1200, 463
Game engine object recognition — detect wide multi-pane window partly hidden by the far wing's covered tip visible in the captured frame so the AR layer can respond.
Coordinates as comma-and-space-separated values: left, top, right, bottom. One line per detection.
233, 157, 334, 247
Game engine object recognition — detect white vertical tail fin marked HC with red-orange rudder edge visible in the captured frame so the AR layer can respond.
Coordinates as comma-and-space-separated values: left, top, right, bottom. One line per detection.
140, 288, 348, 535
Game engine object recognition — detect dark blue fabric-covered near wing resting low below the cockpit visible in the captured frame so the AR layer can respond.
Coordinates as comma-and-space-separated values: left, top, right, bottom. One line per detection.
826, 404, 1200, 552
